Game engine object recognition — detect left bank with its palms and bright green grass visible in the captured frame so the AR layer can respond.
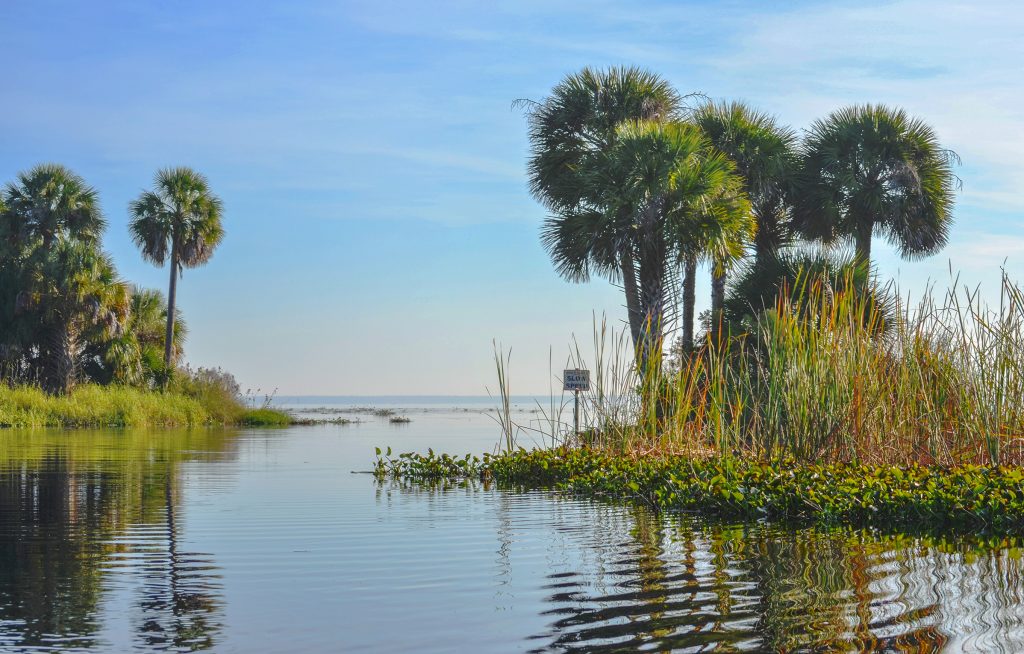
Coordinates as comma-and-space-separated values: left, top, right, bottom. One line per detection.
0, 164, 293, 428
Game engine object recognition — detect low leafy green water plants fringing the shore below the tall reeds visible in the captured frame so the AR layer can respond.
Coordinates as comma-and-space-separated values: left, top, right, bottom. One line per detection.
375, 447, 1024, 535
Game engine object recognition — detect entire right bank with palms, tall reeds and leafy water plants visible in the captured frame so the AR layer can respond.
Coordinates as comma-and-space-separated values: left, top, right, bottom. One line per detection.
376, 68, 1024, 534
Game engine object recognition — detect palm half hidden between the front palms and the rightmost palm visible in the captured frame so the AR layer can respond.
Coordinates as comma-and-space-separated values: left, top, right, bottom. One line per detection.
692, 102, 798, 342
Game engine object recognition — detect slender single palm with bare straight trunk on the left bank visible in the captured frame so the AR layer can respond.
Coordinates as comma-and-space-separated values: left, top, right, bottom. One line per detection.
128, 168, 224, 373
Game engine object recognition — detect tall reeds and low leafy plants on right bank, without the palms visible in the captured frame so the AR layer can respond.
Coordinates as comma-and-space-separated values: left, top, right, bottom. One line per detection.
375, 270, 1024, 537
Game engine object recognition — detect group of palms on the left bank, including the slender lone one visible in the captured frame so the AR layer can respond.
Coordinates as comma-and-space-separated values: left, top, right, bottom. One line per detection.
0, 164, 223, 394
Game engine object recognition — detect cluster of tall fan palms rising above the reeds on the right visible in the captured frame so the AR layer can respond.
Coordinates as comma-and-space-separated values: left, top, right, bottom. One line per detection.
527, 68, 956, 367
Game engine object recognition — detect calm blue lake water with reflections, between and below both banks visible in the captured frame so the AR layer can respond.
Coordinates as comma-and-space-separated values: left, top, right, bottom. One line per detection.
0, 398, 1024, 652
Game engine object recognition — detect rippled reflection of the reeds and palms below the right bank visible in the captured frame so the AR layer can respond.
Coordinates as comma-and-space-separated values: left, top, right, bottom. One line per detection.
378, 474, 1024, 653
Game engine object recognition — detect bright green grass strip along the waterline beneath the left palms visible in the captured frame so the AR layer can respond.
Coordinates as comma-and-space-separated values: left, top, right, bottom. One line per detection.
0, 384, 291, 428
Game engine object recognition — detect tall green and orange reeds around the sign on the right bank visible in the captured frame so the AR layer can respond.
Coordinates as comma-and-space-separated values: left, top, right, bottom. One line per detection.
505, 276, 1024, 465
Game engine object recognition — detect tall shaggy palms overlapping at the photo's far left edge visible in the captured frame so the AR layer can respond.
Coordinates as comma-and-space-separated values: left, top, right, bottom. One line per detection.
0, 164, 126, 393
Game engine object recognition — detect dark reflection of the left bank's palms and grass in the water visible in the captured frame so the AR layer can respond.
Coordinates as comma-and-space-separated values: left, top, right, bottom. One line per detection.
0, 432, 230, 651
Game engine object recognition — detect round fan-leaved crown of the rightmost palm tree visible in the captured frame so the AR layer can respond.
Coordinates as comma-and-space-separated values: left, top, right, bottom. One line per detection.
796, 104, 958, 264
